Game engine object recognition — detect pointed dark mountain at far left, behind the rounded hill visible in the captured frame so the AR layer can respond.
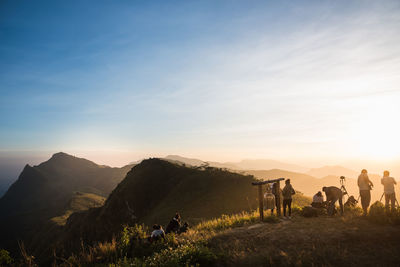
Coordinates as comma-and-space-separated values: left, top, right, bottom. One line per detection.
0, 153, 132, 253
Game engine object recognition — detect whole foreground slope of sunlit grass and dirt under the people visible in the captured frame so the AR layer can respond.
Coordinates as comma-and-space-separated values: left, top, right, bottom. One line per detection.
46, 204, 400, 267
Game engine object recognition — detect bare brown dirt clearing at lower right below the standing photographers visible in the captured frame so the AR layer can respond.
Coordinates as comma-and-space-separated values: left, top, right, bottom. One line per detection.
210, 217, 400, 266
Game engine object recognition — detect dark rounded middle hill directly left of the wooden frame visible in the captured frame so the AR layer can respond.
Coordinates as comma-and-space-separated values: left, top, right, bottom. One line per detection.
60, 159, 257, 247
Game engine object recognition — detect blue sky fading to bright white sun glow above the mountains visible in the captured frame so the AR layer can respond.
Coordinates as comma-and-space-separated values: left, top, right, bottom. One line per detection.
0, 0, 400, 174
